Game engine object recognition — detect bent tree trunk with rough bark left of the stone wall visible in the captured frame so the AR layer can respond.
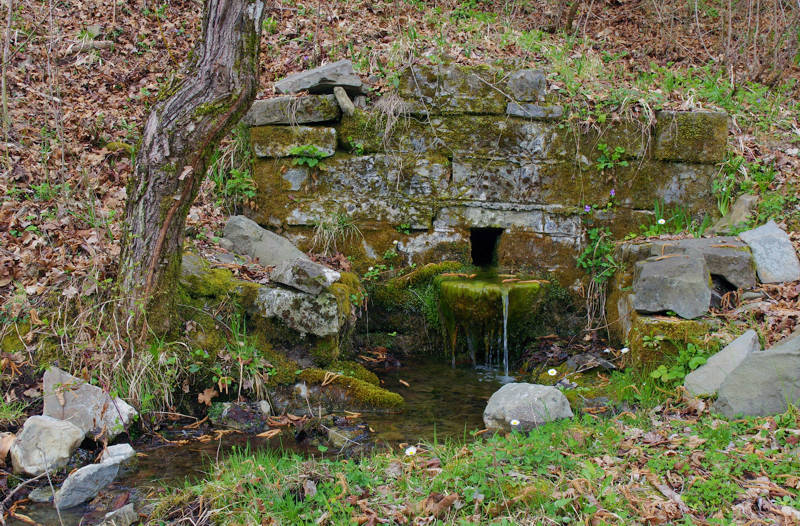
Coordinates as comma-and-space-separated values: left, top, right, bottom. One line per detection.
118, 0, 264, 335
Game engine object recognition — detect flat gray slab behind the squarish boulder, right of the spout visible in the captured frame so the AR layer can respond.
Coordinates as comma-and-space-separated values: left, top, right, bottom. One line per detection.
650, 237, 756, 289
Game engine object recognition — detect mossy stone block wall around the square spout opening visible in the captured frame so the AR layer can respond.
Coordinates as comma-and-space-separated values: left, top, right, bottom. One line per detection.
246, 65, 728, 285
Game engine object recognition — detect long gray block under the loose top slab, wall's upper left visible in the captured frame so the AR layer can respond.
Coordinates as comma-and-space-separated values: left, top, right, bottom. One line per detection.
242, 95, 341, 126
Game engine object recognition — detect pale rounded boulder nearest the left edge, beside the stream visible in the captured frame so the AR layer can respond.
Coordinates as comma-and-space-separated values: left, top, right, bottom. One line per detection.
10, 416, 84, 476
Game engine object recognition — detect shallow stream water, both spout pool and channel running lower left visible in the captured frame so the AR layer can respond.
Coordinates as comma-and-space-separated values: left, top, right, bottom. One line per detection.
8, 357, 510, 526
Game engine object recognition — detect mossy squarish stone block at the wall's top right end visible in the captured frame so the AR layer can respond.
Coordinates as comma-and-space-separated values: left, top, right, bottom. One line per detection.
653, 111, 728, 163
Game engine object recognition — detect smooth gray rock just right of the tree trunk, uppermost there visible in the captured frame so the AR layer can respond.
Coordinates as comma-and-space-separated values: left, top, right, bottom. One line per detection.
223, 216, 307, 267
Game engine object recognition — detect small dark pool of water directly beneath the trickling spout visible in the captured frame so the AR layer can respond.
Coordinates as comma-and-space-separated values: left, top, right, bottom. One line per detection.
364, 357, 514, 446
